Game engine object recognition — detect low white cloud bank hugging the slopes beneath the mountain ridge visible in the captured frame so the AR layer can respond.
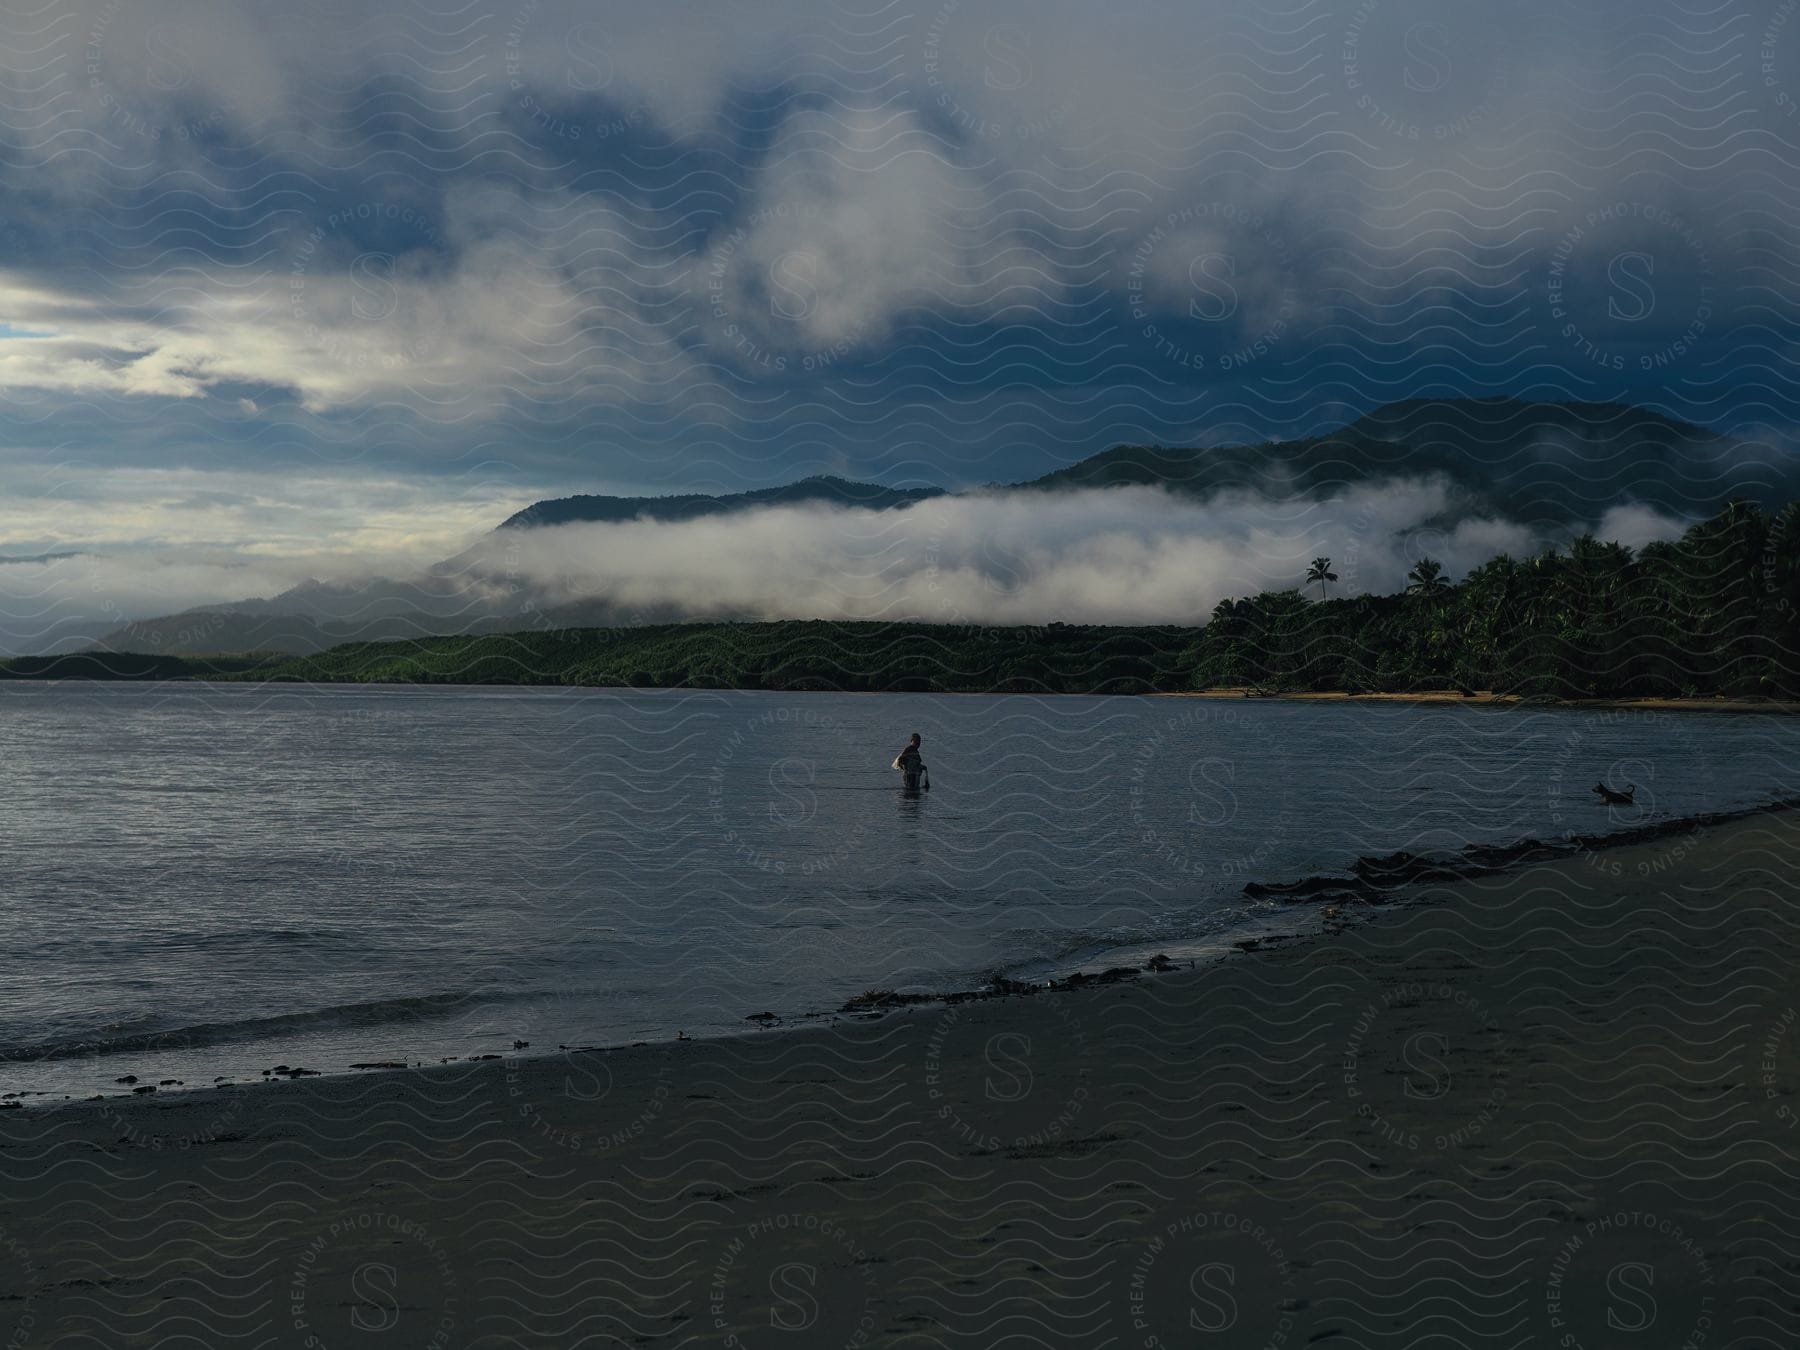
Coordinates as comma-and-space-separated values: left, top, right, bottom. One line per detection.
460, 479, 1683, 623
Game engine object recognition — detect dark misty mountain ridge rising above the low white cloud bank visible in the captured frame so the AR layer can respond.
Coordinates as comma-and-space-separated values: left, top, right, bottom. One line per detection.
81, 396, 1800, 652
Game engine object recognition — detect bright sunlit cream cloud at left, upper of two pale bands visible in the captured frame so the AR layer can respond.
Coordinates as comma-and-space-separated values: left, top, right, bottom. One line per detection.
0, 185, 666, 412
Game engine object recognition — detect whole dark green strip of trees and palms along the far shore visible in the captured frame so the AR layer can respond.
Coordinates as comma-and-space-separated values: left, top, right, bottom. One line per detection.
28, 502, 1800, 698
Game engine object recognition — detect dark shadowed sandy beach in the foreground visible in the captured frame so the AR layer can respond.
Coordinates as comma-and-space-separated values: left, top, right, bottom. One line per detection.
0, 810, 1800, 1350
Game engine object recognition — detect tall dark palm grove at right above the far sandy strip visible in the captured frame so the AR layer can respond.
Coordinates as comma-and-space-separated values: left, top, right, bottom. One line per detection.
1193, 502, 1800, 698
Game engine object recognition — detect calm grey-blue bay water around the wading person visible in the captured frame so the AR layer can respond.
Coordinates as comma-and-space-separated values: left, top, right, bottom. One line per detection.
0, 682, 1800, 1094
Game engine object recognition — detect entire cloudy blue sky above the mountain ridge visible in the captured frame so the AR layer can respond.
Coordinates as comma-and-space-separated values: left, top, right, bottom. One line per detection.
0, 0, 1800, 644
